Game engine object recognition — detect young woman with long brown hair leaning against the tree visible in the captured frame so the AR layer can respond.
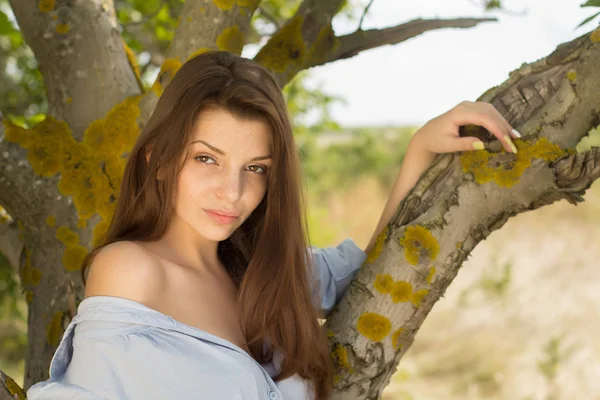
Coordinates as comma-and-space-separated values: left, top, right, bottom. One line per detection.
27, 52, 514, 400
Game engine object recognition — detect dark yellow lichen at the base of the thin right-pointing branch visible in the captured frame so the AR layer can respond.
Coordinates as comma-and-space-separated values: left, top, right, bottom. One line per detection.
255, 15, 306, 72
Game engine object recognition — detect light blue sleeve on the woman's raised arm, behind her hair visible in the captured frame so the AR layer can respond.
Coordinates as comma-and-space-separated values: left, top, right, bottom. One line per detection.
310, 239, 367, 315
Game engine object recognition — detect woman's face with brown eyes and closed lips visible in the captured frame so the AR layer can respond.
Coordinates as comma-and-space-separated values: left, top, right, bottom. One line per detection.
175, 108, 272, 241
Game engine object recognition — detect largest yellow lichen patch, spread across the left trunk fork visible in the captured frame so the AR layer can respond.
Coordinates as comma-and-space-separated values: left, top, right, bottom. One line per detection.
3, 96, 141, 270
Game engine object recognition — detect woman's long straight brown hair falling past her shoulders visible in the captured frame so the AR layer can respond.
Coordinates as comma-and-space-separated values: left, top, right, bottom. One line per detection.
82, 52, 333, 399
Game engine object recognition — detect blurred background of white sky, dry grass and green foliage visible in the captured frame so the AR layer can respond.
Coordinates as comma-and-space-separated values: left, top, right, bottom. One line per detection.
0, 0, 600, 400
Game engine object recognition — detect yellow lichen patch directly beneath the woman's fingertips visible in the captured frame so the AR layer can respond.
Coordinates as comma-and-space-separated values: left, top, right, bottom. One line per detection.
460, 138, 566, 187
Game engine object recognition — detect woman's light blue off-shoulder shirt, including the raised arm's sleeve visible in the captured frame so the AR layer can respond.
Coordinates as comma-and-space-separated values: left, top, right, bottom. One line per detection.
27, 239, 367, 400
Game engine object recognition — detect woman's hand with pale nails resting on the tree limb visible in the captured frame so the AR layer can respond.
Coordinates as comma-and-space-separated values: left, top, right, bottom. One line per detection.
412, 101, 521, 153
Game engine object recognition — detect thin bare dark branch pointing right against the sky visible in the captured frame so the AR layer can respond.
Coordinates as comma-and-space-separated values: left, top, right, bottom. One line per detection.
324, 18, 497, 67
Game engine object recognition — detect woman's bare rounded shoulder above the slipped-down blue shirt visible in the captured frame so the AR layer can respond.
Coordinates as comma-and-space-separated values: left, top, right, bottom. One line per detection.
84, 241, 164, 303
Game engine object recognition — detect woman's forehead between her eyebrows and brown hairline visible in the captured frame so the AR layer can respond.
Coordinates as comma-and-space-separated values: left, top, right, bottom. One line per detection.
190, 108, 273, 150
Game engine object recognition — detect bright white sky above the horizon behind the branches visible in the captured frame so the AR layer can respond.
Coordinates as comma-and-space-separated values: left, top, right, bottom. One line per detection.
288, 0, 600, 126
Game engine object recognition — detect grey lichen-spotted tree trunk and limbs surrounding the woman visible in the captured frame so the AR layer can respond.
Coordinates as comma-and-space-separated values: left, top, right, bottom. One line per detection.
0, 0, 600, 400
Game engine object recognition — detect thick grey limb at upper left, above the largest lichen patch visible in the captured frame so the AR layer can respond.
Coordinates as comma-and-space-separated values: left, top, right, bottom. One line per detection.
10, 0, 139, 139
